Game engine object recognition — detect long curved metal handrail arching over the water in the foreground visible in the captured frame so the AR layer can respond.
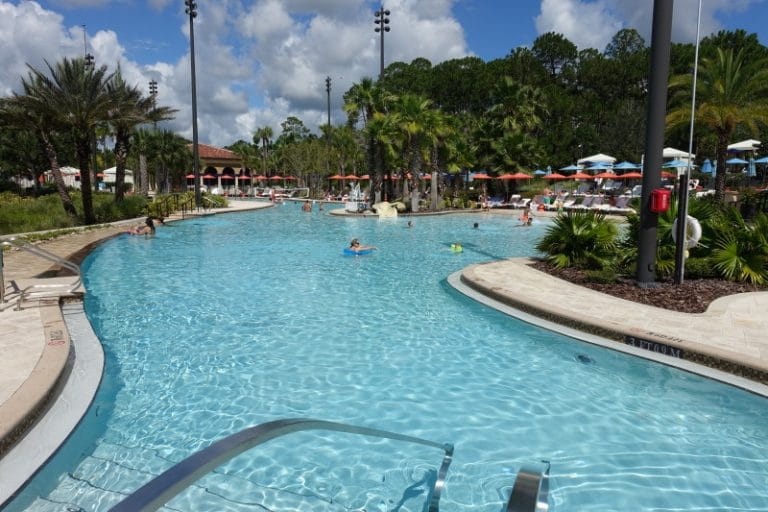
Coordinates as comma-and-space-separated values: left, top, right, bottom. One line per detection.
111, 418, 453, 512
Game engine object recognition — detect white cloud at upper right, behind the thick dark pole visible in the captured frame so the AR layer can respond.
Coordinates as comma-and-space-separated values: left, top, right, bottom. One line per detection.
536, 0, 762, 50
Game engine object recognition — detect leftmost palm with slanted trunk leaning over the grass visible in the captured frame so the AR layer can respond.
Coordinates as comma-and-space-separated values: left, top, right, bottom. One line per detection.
0, 79, 77, 218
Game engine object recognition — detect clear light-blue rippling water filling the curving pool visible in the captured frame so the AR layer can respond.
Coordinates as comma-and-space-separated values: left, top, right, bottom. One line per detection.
9, 204, 768, 512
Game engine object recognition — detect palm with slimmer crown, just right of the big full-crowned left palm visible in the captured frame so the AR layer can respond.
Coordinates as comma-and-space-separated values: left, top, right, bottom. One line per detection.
106, 68, 176, 202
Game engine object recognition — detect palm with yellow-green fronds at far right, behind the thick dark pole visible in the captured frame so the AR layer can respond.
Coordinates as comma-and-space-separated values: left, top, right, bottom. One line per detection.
667, 48, 768, 199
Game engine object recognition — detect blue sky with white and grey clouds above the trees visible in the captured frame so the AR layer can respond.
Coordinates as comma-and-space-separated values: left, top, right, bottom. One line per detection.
0, 0, 768, 145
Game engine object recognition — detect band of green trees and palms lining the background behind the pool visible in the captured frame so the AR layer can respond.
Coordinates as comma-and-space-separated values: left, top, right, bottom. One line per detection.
0, 29, 768, 223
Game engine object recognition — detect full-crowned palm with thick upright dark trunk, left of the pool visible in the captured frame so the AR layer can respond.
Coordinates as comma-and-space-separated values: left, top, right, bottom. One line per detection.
24, 58, 112, 224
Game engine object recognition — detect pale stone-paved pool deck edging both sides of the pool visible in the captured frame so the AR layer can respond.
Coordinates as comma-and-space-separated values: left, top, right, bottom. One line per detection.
0, 200, 768, 504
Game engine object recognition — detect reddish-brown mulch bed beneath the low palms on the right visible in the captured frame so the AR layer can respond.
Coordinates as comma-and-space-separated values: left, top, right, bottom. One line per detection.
533, 262, 768, 313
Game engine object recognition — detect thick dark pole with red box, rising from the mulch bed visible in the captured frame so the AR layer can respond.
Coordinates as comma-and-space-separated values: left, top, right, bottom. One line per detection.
637, 0, 674, 288
